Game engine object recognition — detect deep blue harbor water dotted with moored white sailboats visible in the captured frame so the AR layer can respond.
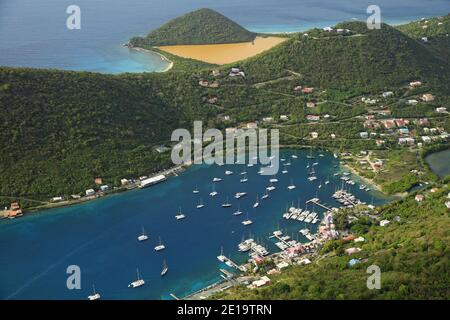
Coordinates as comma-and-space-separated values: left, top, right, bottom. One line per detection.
0, 151, 386, 299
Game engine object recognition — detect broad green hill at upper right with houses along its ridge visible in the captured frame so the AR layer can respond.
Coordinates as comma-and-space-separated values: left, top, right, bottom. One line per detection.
238, 22, 450, 92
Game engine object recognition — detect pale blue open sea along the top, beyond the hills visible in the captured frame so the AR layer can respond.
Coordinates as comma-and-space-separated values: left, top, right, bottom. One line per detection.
0, 0, 450, 73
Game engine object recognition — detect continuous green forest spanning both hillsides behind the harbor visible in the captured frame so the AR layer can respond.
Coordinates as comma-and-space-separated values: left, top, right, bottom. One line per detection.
0, 10, 450, 205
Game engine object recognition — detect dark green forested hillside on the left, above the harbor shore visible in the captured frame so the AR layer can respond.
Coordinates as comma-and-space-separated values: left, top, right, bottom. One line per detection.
0, 68, 208, 204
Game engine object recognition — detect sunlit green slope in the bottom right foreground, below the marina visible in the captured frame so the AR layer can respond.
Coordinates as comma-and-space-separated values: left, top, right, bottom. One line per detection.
216, 187, 450, 299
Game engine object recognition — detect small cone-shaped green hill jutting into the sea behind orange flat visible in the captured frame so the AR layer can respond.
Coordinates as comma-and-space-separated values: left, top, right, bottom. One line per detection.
130, 9, 256, 48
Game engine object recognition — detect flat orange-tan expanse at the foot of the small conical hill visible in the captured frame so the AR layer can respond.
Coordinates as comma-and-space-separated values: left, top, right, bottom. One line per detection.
158, 37, 287, 65
